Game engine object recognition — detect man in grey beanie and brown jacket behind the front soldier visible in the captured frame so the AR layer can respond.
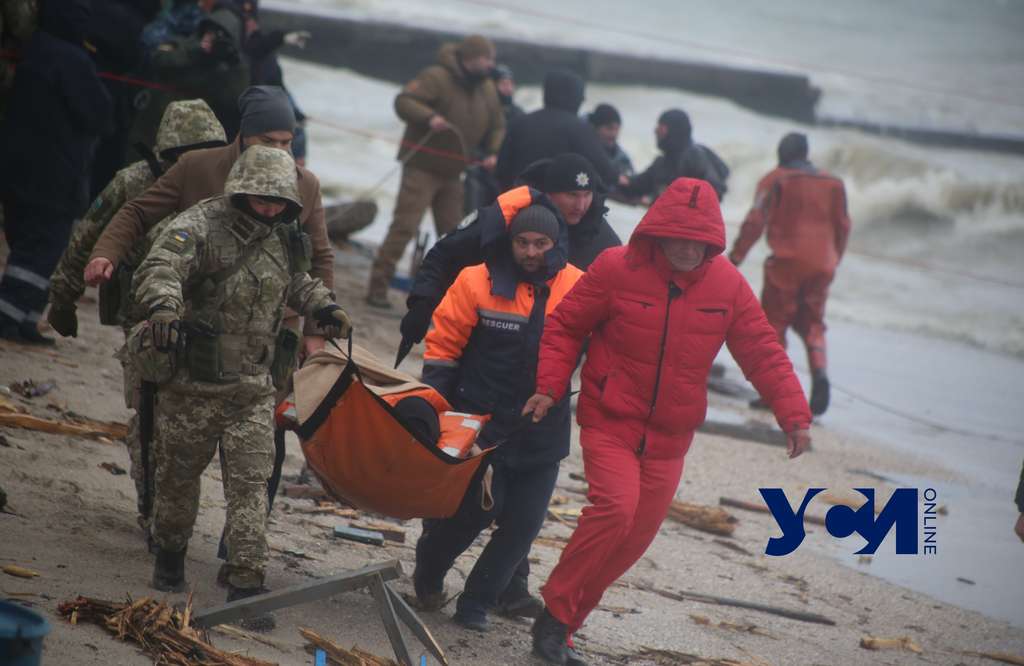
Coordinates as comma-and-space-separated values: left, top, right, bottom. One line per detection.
85, 86, 334, 353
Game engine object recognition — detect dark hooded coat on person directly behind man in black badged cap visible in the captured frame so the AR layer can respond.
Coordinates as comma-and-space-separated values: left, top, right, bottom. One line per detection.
495, 72, 618, 191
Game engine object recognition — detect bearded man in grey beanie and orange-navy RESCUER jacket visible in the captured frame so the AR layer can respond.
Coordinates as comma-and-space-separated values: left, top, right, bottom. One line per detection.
413, 186, 583, 631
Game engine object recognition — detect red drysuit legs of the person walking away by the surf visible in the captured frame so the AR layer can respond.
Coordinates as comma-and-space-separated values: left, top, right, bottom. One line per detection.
761, 257, 835, 372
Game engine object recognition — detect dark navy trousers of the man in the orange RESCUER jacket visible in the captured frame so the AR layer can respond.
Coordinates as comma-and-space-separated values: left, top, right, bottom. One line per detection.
414, 460, 558, 615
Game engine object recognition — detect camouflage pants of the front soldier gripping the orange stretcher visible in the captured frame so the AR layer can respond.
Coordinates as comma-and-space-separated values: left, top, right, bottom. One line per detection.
153, 383, 273, 588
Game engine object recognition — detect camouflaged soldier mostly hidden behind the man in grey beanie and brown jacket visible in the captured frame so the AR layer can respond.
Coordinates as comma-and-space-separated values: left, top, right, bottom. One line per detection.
46, 99, 227, 530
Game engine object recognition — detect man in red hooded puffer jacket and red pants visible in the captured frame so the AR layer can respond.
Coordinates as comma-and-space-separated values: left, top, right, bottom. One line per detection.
523, 178, 811, 664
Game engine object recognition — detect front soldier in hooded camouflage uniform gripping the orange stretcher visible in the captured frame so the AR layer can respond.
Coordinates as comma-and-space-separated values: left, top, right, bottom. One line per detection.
132, 145, 351, 629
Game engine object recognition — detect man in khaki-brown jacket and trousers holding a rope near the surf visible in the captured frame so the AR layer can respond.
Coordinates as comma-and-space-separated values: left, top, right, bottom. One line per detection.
367, 35, 505, 307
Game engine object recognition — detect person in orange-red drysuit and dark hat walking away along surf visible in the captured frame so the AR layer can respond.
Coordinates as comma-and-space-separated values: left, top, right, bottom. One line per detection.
729, 132, 850, 416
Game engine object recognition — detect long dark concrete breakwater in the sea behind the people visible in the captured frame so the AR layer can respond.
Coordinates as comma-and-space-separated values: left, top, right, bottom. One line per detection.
260, 2, 1024, 155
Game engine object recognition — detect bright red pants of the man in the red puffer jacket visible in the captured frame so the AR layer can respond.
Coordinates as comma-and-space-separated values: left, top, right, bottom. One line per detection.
541, 428, 683, 635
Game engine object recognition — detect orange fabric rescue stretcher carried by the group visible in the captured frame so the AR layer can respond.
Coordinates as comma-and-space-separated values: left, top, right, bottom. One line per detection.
286, 340, 488, 518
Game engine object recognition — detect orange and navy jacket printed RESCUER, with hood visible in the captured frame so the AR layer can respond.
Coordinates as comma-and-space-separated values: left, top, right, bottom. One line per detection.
423, 188, 582, 468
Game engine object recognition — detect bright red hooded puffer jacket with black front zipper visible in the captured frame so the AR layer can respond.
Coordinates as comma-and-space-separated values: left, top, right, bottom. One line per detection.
537, 178, 811, 458
